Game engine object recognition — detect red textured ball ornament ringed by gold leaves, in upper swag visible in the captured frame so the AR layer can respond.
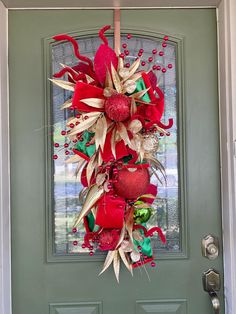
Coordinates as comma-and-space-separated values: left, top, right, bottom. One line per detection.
105, 94, 131, 121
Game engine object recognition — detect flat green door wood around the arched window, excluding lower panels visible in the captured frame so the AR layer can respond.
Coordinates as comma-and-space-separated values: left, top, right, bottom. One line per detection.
9, 9, 224, 314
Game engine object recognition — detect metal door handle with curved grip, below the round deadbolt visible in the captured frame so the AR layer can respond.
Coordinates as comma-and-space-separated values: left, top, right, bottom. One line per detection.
202, 269, 220, 314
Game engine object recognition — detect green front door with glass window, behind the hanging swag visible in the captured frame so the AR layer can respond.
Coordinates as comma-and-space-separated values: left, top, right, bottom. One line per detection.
9, 9, 224, 314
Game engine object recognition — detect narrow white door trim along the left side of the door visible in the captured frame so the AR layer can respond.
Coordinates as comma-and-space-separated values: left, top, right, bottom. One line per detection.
0, 1, 11, 314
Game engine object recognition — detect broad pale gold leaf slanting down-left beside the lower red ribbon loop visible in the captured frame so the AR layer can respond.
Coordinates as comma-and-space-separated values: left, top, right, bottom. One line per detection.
74, 184, 104, 227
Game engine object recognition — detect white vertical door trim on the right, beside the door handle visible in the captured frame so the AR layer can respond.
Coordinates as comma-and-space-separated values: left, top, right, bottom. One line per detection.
217, 0, 236, 314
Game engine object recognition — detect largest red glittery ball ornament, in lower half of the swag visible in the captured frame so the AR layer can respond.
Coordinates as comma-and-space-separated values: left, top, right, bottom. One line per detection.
113, 168, 150, 199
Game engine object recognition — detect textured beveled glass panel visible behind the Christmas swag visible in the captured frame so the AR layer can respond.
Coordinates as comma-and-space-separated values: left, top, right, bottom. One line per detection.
51, 35, 179, 256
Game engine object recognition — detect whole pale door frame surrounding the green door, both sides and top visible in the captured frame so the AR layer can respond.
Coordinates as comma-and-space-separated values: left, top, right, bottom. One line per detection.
0, 0, 236, 314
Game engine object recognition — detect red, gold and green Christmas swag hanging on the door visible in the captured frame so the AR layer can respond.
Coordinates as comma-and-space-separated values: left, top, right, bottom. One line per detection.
51, 26, 173, 281
